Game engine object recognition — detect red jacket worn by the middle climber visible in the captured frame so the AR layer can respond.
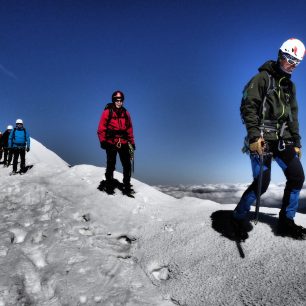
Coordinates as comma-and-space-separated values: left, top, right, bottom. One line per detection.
98, 104, 135, 144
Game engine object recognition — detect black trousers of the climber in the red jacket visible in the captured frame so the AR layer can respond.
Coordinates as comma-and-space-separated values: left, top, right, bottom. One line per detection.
105, 144, 132, 185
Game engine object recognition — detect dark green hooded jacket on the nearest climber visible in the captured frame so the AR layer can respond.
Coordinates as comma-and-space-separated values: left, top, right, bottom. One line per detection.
240, 61, 301, 147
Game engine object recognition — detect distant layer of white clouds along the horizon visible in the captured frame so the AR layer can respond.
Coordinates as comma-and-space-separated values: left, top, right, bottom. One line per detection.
156, 183, 306, 213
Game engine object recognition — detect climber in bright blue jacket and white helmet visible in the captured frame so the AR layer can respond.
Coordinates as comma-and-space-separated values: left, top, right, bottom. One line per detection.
9, 119, 30, 174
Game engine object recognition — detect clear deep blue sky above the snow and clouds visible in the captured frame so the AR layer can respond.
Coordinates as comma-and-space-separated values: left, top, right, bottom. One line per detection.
0, 0, 306, 185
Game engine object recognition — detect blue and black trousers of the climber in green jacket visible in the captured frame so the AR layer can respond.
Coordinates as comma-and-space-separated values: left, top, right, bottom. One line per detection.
234, 142, 305, 220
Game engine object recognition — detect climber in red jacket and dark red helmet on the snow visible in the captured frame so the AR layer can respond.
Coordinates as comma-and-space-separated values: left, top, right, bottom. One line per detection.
97, 90, 135, 194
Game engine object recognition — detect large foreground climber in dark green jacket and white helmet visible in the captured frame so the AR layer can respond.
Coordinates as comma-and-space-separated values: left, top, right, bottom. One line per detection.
233, 38, 306, 240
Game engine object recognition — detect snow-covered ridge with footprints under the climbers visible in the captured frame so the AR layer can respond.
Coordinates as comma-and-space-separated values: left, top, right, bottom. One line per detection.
0, 140, 306, 306
